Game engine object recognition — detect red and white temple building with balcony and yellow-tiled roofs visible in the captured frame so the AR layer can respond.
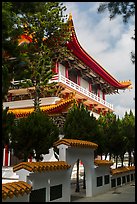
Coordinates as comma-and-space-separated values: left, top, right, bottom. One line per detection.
3, 14, 132, 118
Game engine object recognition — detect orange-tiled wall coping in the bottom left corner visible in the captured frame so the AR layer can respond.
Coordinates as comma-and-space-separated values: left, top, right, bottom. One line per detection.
2, 181, 32, 200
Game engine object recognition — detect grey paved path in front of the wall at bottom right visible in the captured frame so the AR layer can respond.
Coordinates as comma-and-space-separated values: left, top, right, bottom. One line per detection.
71, 182, 135, 202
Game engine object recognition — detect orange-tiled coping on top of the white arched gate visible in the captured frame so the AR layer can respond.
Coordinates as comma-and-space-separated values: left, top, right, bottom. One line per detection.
53, 139, 98, 149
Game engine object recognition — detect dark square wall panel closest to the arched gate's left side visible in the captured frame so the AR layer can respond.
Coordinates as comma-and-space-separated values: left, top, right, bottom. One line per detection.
50, 184, 62, 201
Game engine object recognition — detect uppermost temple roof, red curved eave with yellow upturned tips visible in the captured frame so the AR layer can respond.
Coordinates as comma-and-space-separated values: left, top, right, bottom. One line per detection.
66, 14, 131, 89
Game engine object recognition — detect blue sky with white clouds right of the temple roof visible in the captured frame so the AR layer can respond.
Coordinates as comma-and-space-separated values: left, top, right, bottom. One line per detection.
63, 2, 135, 118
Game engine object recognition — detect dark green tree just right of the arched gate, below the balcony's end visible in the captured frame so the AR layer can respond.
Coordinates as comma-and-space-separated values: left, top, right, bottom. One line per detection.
98, 112, 125, 168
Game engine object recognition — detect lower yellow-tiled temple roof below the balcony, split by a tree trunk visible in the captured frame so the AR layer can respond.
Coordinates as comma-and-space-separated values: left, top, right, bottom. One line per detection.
8, 97, 74, 118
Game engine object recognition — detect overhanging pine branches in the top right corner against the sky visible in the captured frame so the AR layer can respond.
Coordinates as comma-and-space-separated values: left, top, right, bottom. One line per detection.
98, 2, 135, 63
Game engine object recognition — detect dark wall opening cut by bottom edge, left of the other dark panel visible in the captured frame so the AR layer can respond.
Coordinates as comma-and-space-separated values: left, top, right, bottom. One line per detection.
30, 188, 46, 202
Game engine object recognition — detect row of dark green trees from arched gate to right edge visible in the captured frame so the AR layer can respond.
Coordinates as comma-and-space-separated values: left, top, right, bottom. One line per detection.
98, 111, 135, 168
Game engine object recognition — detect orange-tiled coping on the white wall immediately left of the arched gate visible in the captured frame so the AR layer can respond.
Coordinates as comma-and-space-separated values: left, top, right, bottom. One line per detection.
13, 161, 70, 172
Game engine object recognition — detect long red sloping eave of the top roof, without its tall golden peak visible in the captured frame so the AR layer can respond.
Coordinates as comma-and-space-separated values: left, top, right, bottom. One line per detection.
66, 32, 129, 89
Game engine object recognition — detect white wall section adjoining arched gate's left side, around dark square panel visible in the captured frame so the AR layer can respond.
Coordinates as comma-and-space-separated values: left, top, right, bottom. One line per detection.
28, 170, 70, 202
